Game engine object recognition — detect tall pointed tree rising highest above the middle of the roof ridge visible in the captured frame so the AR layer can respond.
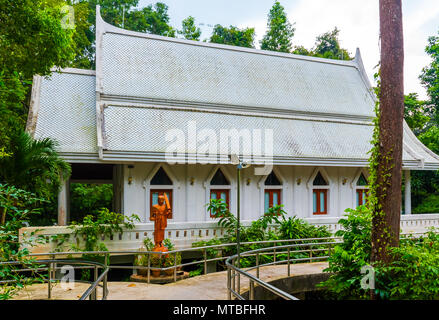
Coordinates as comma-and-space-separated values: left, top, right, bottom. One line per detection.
261, 1, 296, 52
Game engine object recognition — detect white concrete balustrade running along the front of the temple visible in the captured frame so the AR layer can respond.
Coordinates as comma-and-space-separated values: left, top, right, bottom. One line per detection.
20, 214, 439, 253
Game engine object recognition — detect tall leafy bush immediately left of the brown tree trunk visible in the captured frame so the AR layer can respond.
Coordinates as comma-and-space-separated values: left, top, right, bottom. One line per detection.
321, 206, 372, 299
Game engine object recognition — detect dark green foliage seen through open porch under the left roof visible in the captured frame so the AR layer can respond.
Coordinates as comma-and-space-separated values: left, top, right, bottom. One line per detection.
70, 183, 113, 221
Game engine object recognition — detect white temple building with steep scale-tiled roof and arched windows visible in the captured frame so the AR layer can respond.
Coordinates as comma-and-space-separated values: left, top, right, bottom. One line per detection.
27, 6, 439, 248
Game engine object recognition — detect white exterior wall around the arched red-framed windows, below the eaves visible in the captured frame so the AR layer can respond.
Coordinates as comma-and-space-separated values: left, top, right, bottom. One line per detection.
123, 163, 367, 223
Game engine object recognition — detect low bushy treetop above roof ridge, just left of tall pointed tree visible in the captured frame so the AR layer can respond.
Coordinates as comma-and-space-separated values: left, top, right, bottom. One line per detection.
210, 24, 255, 48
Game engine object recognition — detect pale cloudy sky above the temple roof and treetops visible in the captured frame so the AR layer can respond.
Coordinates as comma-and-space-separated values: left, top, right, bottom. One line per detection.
139, 0, 439, 99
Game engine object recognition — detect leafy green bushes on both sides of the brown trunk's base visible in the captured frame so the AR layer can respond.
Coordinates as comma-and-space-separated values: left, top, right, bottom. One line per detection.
320, 206, 439, 300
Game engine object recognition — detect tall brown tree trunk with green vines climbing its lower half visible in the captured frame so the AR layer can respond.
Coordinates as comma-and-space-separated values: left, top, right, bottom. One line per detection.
371, 0, 404, 263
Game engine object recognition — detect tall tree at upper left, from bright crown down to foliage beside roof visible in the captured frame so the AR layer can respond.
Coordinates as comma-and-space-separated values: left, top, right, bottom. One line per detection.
0, 0, 75, 148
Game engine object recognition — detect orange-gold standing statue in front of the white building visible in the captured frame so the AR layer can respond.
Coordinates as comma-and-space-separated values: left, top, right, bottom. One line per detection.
151, 193, 171, 251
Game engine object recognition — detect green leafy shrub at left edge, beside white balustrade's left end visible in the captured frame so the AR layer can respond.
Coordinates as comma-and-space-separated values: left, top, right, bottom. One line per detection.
0, 184, 45, 300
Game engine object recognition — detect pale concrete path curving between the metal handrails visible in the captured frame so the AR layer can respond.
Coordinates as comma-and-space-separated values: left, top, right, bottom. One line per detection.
15, 262, 328, 300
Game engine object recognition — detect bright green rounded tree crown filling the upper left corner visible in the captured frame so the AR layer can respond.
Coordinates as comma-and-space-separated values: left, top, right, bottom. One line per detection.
0, 0, 74, 80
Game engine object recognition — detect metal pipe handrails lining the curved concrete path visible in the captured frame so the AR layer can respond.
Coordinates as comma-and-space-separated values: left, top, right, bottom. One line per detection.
5, 232, 432, 300
